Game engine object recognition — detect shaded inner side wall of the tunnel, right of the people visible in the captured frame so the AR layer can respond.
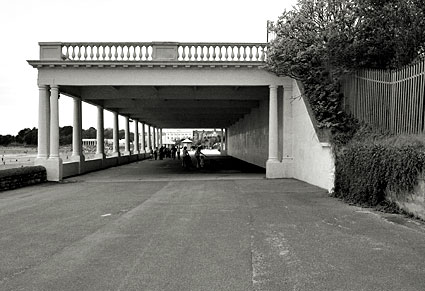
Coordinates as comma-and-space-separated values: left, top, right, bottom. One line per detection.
227, 100, 269, 168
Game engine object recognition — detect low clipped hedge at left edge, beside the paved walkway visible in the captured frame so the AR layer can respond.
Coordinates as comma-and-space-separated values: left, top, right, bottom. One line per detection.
0, 166, 47, 191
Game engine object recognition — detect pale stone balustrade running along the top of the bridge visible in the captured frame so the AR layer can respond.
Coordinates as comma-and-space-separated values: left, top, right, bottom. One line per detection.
39, 42, 267, 62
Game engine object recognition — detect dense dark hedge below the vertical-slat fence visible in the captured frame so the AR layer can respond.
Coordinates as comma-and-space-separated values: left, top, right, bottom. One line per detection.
334, 141, 425, 206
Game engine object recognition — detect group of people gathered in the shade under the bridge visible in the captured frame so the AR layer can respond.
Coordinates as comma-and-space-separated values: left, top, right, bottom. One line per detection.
150, 145, 206, 169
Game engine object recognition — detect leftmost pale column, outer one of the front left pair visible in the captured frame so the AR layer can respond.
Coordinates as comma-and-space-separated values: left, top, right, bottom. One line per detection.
35, 85, 50, 165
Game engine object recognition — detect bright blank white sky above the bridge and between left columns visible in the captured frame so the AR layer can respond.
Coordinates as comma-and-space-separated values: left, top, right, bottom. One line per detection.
0, 0, 297, 135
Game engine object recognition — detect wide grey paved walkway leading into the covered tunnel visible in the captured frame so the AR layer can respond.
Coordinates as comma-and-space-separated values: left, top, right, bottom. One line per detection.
0, 160, 425, 291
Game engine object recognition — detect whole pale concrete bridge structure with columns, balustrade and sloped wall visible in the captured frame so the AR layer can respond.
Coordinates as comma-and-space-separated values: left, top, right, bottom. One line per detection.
28, 42, 334, 190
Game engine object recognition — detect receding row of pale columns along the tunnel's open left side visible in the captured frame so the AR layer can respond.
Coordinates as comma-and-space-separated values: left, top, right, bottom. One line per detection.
35, 85, 162, 181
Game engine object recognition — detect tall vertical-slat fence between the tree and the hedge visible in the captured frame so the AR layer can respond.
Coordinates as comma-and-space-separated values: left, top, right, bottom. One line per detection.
342, 59, 425, 134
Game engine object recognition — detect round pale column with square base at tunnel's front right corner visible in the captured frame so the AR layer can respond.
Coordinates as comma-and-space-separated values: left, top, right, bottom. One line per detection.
266, 85, 283, 178
